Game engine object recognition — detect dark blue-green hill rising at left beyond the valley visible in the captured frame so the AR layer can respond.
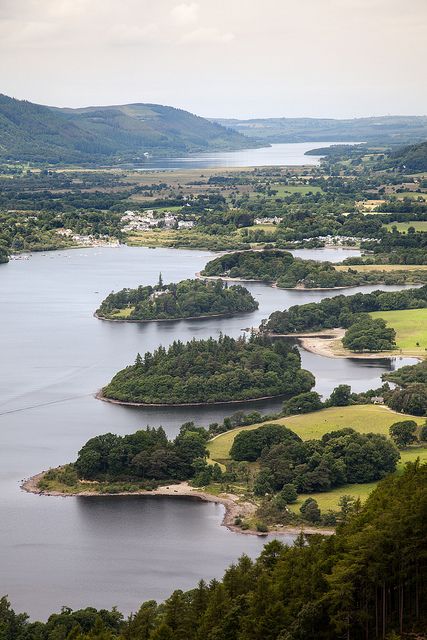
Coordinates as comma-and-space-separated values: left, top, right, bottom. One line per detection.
0, 94, 257, 163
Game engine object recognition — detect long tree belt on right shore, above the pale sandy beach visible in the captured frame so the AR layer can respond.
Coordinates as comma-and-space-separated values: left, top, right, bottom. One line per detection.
262, 286, 427, 334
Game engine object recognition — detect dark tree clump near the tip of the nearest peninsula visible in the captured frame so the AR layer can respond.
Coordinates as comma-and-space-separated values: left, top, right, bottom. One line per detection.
74, 423, 206, 481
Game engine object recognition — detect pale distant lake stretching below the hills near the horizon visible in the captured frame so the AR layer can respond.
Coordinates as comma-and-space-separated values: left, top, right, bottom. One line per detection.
137, 142, 357, 171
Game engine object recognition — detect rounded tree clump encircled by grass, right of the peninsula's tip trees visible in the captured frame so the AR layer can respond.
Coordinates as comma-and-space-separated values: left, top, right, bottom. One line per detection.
230, 424, 400, 495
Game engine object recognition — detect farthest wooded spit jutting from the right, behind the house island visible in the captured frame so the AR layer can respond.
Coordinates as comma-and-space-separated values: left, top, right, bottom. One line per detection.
201, 249, 426, 289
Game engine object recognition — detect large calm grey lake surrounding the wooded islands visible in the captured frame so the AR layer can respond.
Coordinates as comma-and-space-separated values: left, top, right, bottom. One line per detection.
0, 247, 411, 618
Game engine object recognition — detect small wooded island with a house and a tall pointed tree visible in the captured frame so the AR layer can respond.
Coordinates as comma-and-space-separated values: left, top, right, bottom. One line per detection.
95, 275, 258, 322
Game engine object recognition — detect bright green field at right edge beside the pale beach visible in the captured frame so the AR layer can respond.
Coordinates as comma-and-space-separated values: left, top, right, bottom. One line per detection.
370, 309, 427, 356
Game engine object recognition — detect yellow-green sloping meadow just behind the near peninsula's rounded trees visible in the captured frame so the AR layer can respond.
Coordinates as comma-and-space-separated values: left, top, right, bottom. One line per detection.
208, 404, 424, 461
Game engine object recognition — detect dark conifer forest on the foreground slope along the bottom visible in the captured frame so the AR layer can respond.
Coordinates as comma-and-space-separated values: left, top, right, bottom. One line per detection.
0, 463, 427, 640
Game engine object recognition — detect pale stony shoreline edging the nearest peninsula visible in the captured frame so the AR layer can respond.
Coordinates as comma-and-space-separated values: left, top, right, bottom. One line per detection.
20, 471, 335, 537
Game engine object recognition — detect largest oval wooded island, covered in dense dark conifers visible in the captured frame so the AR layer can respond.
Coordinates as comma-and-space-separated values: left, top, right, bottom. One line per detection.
102, 336, 314, 405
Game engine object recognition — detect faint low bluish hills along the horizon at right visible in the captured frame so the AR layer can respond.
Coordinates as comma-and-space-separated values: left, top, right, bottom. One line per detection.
212, 116, 427, 145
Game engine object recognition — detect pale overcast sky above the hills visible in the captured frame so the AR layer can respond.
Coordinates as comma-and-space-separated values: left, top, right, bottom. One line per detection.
0, 0, 427, 118
